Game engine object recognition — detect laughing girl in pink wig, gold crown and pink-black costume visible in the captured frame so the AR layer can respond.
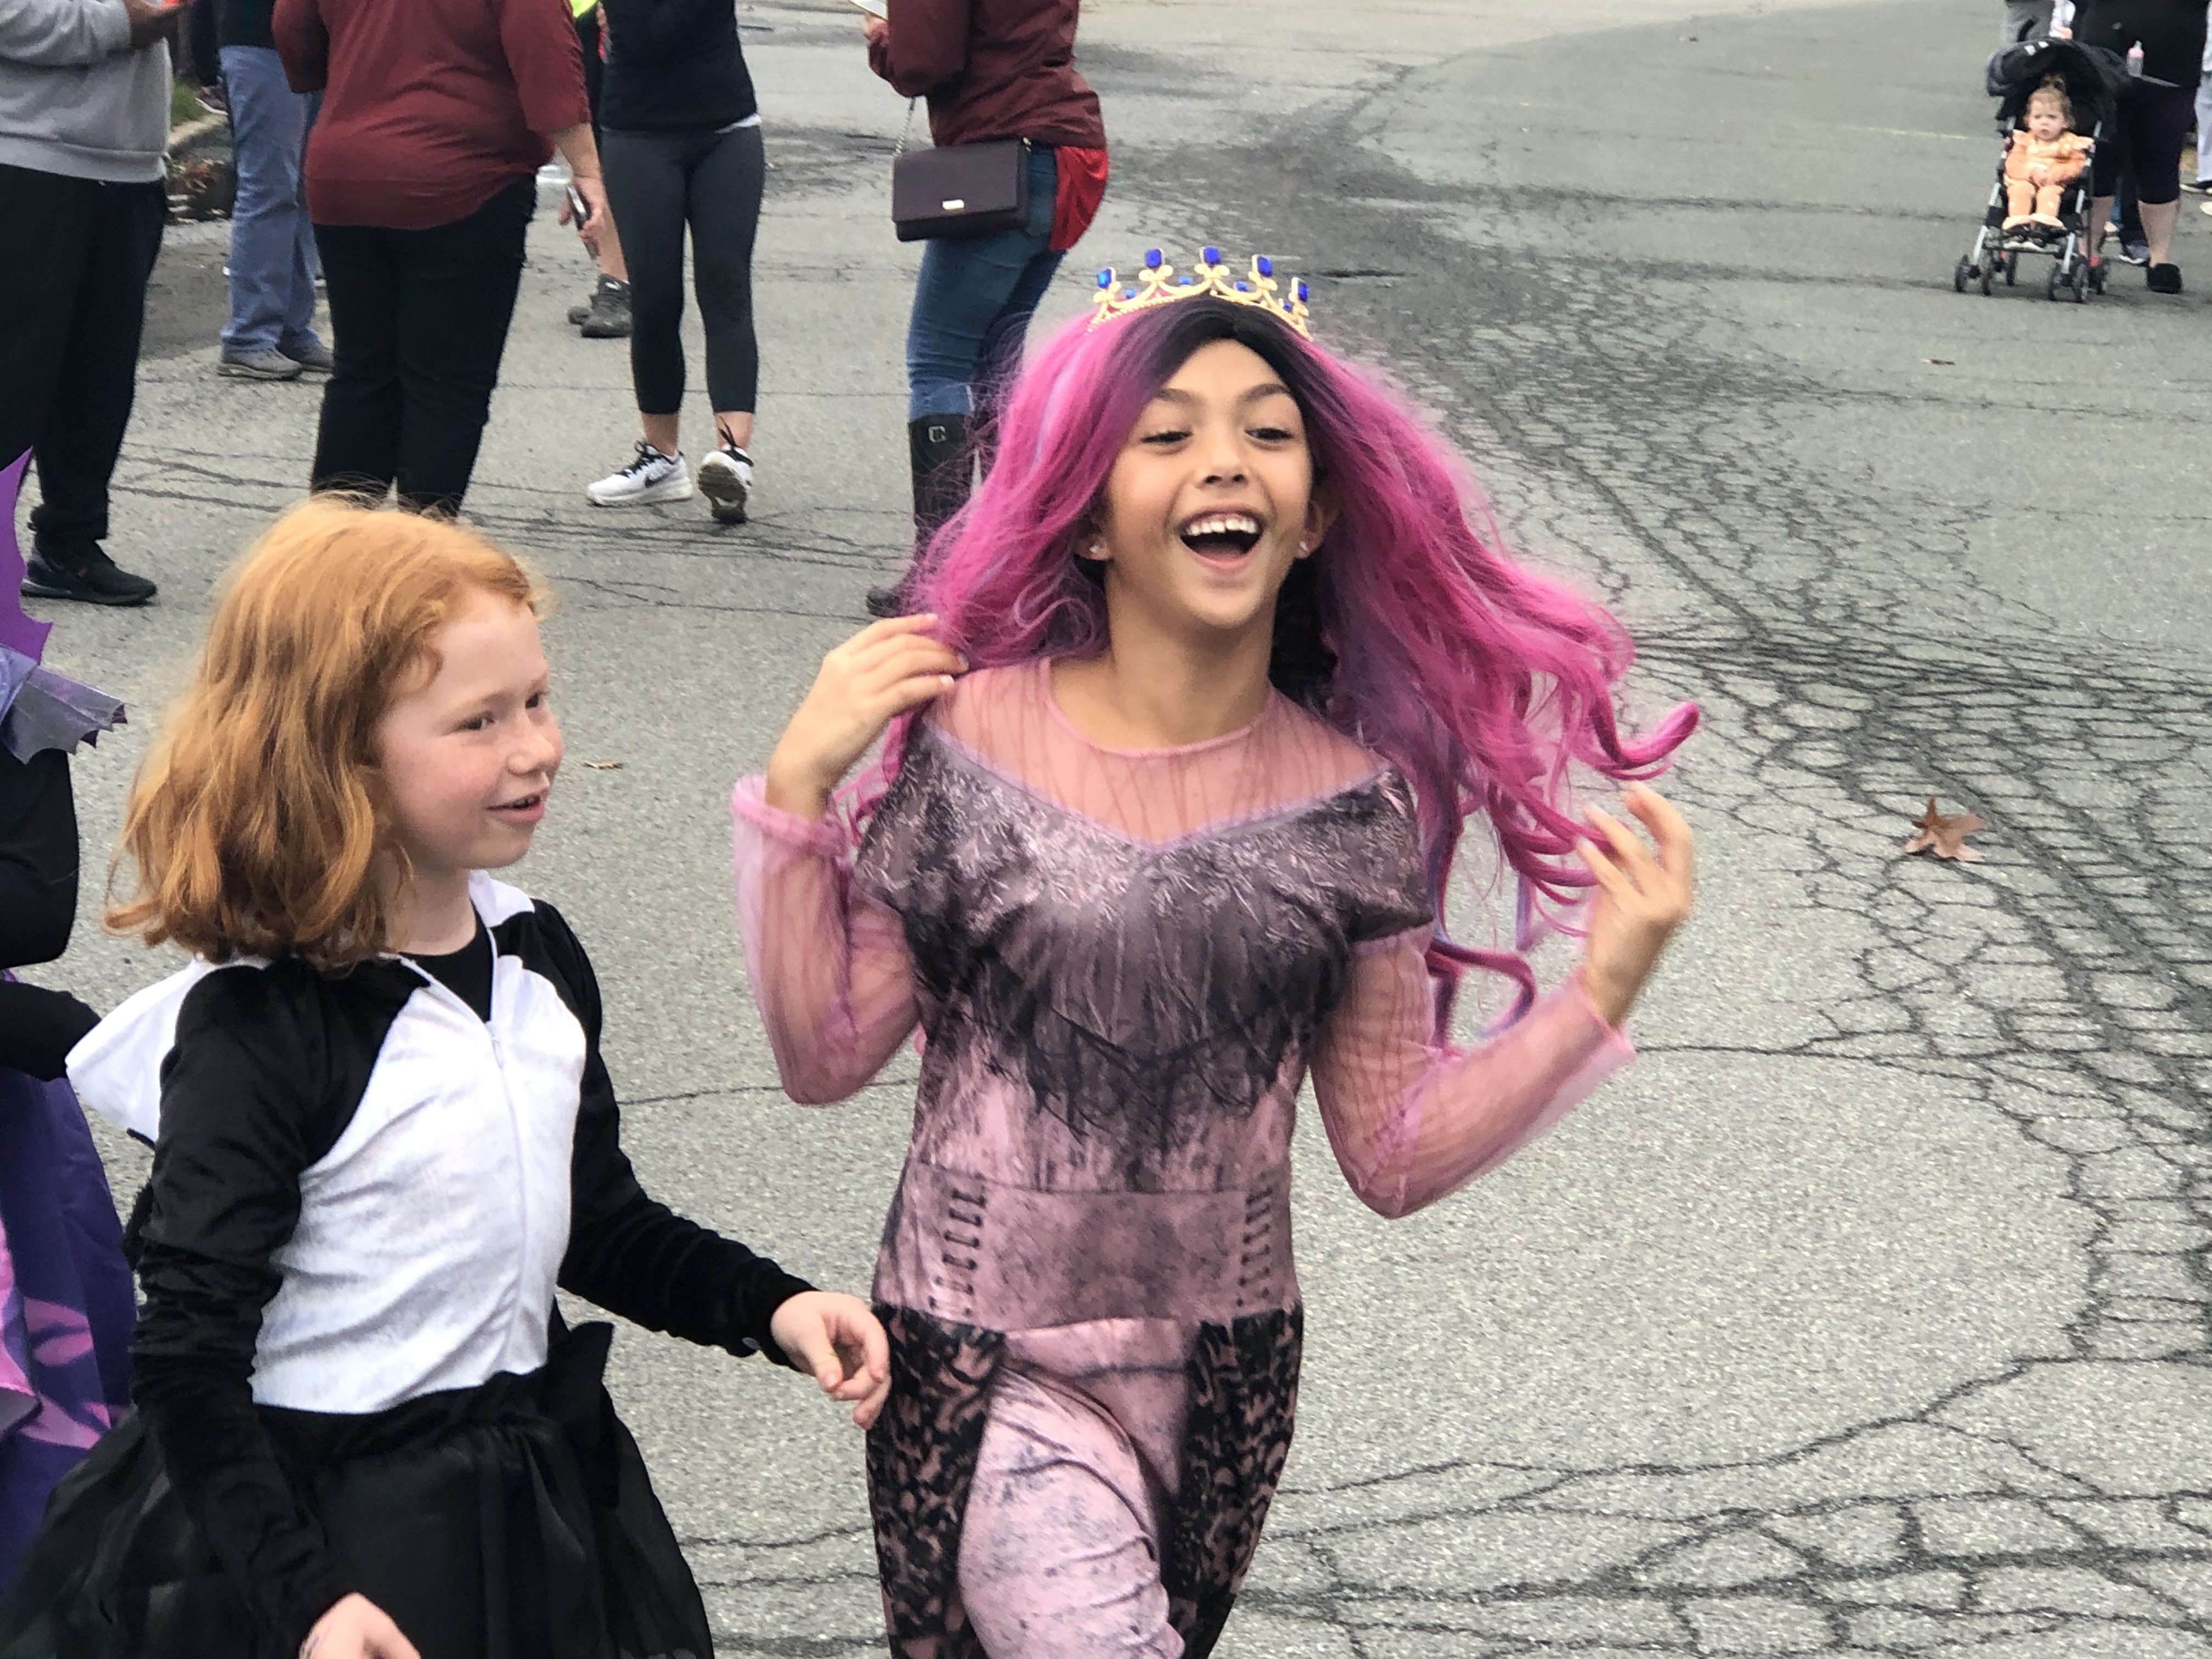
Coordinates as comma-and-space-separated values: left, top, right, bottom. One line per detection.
735, 259, 1695, 1659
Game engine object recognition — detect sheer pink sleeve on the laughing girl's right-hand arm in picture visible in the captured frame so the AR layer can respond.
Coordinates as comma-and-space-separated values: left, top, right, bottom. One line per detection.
1314, 929, 1635, 1217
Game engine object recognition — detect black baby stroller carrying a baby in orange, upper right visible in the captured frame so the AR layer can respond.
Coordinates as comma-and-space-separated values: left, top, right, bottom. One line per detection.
1951, 40, 2128, 303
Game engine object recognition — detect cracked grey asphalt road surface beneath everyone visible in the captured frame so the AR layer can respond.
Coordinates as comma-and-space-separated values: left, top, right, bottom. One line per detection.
21, 0, 2212, 1659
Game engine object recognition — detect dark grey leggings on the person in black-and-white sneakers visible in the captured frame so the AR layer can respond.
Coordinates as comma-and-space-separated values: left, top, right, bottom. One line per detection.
600, 126, 768, 414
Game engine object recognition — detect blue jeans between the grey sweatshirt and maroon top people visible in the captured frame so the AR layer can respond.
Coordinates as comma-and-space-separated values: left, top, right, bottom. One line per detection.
223, 47, 317, 356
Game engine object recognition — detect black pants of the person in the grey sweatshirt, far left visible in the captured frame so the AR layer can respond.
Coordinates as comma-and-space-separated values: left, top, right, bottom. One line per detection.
0, 166, 168, 546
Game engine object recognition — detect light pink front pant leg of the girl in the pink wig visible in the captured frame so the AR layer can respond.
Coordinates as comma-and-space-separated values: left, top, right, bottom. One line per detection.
960, 1367, 1183, 1659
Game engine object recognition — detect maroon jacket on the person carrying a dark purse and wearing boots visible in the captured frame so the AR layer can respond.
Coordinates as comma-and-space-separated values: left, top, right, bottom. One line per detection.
867, 0, 1106, 150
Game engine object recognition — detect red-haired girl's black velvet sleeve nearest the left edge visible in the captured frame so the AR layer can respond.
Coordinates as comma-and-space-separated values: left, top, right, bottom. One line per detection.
131, 962, 358, 1652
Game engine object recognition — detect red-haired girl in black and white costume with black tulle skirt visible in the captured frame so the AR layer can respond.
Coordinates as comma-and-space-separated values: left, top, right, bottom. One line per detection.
0, 502, 887, 1659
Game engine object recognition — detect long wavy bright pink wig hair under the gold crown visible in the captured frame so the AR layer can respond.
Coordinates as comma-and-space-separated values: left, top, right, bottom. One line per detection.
862, 298, 1697, 1035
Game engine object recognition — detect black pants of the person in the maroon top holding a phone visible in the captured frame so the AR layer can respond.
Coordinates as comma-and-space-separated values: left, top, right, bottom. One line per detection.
309, 179, 538, 513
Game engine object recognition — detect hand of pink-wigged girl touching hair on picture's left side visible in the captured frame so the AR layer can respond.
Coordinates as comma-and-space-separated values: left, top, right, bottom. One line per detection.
765, 615, 967, 819
